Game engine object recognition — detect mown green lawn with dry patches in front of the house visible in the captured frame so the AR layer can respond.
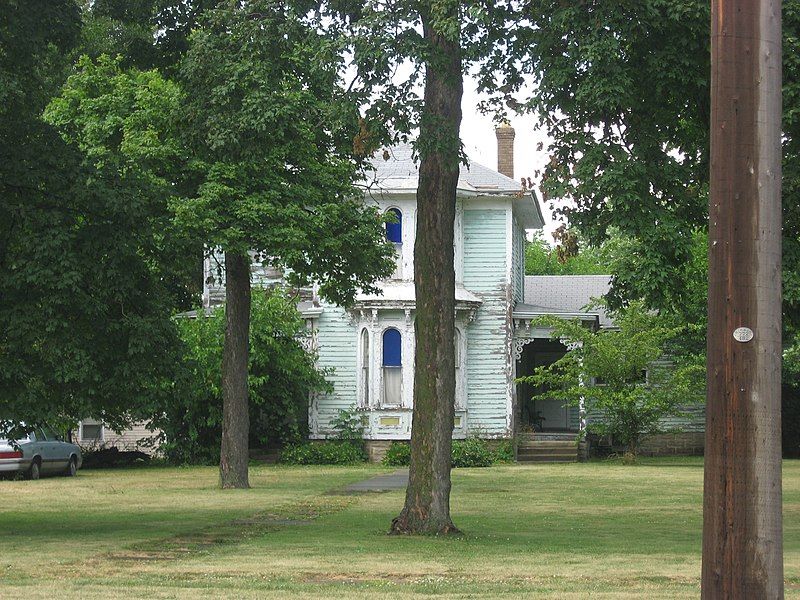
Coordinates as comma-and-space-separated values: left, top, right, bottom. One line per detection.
0, 459, 800, 599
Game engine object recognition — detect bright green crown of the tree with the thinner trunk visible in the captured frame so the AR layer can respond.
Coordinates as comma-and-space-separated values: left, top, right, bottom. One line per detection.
173, 0, 394, 305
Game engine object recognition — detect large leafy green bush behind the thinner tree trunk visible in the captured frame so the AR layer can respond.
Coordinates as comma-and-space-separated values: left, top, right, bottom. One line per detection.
152, 290, 329, 464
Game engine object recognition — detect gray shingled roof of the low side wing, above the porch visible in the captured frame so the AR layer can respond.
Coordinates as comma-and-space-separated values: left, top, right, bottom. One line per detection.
515, 275, 614, 327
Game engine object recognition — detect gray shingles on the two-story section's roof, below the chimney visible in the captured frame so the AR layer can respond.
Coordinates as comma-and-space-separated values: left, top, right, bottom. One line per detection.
370, 144, 522, 194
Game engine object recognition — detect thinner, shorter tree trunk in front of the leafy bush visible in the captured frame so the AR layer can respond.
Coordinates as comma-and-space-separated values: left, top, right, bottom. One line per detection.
219, 252, 250, 488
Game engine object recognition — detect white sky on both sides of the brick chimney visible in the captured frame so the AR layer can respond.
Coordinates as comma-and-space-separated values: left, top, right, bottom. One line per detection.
461, 76, 557, 241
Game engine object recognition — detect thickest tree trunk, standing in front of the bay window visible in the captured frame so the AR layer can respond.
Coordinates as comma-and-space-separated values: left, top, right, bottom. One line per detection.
391, 2, 463, 534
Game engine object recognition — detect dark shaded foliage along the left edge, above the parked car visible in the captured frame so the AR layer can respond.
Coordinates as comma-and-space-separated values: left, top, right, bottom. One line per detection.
0, 1, 191, 427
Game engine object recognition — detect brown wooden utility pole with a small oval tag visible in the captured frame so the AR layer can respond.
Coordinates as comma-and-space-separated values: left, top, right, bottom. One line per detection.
702, 0, 783, 600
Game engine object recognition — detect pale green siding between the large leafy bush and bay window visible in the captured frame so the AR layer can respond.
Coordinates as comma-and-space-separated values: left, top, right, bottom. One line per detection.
311, 306, 357, 433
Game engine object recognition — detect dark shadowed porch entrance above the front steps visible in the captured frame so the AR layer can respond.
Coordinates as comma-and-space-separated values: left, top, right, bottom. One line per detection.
517, 339, 578, 432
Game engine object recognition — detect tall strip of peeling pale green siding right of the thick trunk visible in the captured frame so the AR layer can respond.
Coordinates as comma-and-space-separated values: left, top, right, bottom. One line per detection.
464, 209, 510, 436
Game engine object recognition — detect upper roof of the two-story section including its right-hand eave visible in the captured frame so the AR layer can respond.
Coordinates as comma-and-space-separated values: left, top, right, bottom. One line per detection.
366, 144, 544, 229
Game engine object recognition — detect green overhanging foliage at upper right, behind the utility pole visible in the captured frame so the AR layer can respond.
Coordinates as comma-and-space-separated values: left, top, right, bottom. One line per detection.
475, 0, 800, 354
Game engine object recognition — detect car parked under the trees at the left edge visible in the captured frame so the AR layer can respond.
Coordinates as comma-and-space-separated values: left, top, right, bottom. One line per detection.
0, 428, 83, 479
